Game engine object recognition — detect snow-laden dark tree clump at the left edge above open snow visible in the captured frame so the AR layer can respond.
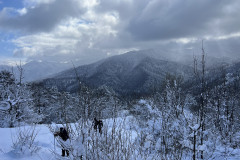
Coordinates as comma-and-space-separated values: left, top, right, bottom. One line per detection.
0, 71, 41, 127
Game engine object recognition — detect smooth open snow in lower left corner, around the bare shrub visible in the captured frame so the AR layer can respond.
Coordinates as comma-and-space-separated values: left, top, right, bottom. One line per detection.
0, 125, 55, 160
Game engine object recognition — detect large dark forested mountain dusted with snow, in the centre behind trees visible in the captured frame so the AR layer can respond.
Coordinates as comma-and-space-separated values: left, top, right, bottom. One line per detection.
44, 50, 193, 95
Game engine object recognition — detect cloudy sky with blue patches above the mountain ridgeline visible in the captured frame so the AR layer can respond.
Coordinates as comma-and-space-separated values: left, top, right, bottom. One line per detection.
0, 0, 240, 63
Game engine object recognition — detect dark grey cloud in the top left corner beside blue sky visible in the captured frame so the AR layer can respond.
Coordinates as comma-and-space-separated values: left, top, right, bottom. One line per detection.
0, 0, 84, 32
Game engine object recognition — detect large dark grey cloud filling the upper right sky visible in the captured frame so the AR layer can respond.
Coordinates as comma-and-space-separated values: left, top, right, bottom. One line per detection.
124, 0, 240, 40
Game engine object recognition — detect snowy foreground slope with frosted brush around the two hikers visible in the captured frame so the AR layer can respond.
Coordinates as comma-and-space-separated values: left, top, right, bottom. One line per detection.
0, 100, 240, 160
